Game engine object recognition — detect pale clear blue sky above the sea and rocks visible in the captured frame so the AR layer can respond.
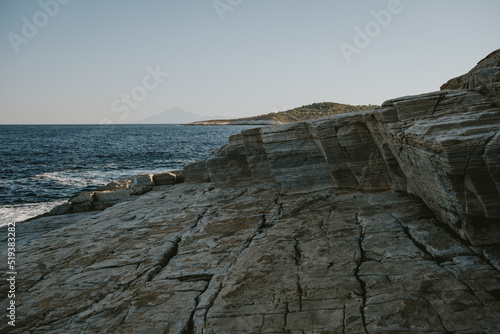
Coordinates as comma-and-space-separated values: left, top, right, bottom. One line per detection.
0, 0, 500, 124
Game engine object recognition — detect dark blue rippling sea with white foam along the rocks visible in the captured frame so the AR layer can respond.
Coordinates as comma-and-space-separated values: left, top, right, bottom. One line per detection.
0, 124, 250, 226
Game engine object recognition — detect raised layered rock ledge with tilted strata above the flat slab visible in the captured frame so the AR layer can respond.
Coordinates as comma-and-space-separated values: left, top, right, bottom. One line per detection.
185, 90, 500, 245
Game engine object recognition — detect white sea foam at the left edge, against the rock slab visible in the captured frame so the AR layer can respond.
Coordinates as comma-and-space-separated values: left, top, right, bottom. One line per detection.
0, 201, 65, 226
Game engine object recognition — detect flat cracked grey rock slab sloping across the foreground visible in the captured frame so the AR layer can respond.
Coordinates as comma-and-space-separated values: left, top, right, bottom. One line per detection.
0, 183, 500, 333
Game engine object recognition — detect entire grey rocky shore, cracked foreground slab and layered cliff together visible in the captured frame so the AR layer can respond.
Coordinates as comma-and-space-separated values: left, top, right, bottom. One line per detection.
0, 51, 500, 333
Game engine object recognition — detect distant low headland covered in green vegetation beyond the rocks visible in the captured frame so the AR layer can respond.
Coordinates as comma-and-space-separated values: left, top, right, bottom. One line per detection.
188, 102, 378, 125
